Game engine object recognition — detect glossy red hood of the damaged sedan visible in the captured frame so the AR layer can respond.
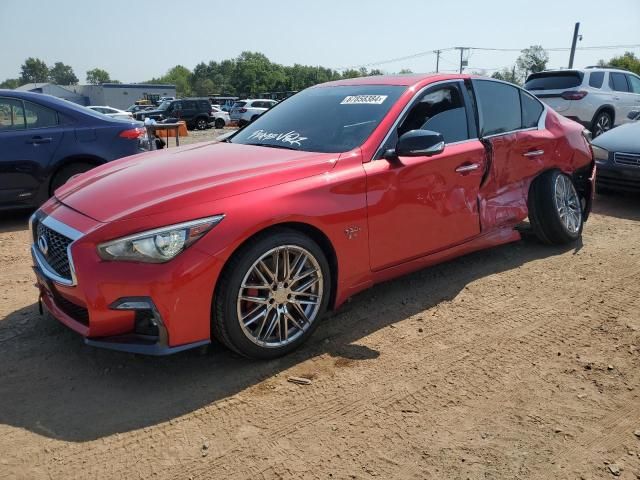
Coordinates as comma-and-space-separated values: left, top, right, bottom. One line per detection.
55, 142, 339, 222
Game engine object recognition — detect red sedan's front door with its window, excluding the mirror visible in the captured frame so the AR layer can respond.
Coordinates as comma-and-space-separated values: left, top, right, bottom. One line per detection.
364, 81, 486, 270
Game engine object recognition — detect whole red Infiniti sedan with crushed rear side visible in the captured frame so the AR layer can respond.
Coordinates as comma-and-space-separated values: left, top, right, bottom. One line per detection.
31, 75, 595, 358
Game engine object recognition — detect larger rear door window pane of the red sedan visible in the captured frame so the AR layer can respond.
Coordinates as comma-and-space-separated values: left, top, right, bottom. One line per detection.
473, 80, 522, 137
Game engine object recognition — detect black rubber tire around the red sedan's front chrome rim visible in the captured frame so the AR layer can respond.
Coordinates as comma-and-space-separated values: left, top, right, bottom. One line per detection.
211, 228, 331, 359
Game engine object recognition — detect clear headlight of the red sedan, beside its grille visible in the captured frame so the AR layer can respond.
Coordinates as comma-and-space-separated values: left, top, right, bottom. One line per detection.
98, 215, 224, 263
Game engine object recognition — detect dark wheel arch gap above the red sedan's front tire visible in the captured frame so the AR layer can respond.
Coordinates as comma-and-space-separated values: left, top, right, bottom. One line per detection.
211, 221, 338, 311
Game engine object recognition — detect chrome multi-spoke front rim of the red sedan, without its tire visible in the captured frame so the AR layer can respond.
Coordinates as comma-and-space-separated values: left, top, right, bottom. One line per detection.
237, 245, 324, 348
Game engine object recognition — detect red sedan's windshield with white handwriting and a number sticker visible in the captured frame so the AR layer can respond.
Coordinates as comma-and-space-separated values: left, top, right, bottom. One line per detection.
229, 85, 407, 153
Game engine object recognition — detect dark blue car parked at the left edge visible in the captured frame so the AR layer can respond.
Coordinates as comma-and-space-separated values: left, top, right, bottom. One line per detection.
0, 90, 144, 209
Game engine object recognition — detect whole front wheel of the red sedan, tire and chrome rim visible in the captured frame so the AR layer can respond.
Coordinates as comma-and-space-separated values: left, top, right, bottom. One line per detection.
212, 229, 331, 359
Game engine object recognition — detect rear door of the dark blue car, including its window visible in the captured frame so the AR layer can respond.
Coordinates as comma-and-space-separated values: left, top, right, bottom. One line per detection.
0, 97, 64, 203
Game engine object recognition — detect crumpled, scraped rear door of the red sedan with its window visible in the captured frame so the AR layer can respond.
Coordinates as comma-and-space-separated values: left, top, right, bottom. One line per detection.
472, 79, 556, 231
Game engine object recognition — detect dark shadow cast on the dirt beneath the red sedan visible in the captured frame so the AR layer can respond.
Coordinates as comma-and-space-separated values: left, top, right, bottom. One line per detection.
0, 233, 573, 442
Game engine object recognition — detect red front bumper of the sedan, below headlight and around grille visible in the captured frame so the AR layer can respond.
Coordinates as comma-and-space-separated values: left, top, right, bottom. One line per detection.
32, 202, 221, 355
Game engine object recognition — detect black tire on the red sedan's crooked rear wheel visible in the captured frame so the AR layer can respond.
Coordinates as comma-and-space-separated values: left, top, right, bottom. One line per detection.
529, 170, 584, 245
